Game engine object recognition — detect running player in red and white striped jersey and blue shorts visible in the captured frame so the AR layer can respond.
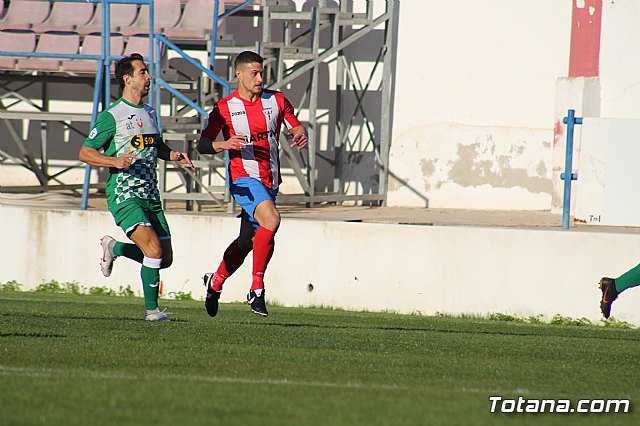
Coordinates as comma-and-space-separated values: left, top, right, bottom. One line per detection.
198, 51, 308, 317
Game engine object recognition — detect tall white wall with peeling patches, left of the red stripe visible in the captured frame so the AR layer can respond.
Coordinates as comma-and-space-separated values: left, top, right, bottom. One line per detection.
388, 0, 571, 209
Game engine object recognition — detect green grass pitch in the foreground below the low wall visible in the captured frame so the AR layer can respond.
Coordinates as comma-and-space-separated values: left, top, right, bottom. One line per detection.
0, 291, 640, 426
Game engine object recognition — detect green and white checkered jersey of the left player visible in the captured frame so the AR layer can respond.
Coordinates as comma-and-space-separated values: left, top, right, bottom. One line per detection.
84, 98, 161, 205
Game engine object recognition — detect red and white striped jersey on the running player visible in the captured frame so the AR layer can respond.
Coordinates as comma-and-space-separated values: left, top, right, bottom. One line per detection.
202, 89, 300, 189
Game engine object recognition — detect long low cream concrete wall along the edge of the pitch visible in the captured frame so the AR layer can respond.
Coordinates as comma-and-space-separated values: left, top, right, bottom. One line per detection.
0, 206, 640, 325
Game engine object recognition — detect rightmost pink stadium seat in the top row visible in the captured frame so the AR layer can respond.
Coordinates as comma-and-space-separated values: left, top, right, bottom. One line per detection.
163, 0, 219, 40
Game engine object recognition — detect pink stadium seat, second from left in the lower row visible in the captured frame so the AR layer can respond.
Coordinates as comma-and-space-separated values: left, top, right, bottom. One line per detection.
17, 31, 80, 71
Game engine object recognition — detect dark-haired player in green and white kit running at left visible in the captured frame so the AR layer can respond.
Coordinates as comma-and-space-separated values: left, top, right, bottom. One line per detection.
80, 53, 193, 321
